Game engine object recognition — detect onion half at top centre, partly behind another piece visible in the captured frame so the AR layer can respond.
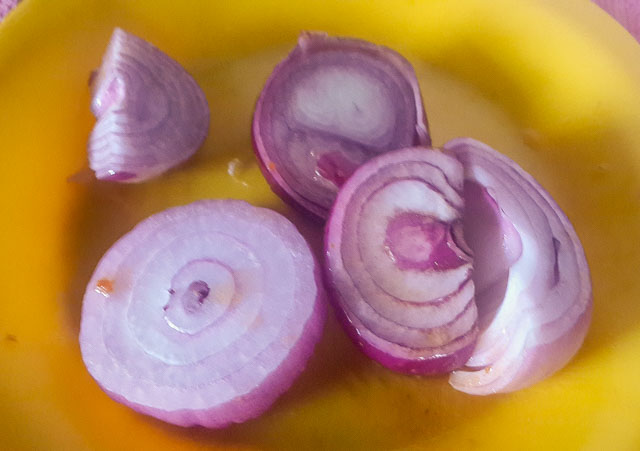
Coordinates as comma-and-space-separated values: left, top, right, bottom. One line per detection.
253, 33, 430, 218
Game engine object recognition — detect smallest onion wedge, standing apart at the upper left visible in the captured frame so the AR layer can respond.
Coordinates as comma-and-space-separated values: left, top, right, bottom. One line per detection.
88, 28, 209, 182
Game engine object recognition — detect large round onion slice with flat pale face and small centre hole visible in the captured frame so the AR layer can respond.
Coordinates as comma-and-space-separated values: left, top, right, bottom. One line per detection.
80, 200, 325, 428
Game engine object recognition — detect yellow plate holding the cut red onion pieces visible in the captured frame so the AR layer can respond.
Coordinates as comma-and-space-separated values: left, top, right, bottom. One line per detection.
0, 0, 640, 450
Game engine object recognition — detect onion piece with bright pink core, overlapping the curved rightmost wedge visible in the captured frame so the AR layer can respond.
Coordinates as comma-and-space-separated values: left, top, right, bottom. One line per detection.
325, 148, 478, 374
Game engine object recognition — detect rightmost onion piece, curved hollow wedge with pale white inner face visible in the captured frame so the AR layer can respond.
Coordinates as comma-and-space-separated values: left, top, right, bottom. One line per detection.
444, 139, 592, 395
